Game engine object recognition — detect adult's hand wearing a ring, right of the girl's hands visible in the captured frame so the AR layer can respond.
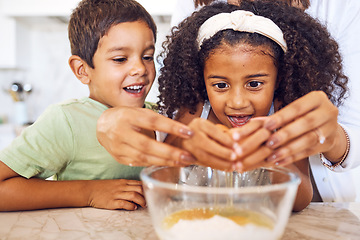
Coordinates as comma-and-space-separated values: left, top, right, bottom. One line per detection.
258, 91, 346, 164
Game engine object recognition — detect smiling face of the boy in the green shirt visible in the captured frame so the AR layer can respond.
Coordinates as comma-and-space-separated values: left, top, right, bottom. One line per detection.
86, 21, 155, 107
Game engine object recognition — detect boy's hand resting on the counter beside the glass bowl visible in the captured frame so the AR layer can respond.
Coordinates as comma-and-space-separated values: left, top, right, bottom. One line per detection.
88, 179, 146, 210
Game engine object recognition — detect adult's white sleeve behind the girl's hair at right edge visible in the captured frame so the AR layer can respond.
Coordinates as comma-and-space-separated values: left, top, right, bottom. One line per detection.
307, 0, 360, 172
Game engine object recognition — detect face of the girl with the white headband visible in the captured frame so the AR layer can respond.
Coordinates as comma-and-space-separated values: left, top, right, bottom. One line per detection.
204, 44, 277, 127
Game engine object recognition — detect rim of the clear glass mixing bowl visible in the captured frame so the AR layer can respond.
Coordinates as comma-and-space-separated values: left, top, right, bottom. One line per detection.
140, 166, 300, 194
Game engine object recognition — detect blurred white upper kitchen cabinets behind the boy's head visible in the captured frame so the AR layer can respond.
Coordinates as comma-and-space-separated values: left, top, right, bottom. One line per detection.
0, 0, 176, 69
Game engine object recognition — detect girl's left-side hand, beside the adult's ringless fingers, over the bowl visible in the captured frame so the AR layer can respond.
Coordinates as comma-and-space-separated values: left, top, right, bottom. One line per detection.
182, 118, 236, 171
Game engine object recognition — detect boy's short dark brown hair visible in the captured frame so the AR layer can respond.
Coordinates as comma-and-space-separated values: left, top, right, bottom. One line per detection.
68, 0, 156, 68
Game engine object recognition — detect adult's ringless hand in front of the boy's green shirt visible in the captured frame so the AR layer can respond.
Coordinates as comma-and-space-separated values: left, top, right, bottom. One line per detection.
97, 107, 193, 166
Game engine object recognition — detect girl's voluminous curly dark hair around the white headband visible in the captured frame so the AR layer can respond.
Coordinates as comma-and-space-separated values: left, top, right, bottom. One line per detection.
158, 0, 348, 117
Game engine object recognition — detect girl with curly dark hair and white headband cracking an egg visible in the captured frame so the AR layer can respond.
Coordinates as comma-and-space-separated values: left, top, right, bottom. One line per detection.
159, 1, 347, 210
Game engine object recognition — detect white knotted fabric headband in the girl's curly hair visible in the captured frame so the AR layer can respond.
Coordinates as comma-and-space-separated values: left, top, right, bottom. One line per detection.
197, 10, 287, 52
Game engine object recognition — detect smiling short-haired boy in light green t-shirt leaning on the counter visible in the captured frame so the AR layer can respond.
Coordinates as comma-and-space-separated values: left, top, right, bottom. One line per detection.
0, 0, 156, 211
